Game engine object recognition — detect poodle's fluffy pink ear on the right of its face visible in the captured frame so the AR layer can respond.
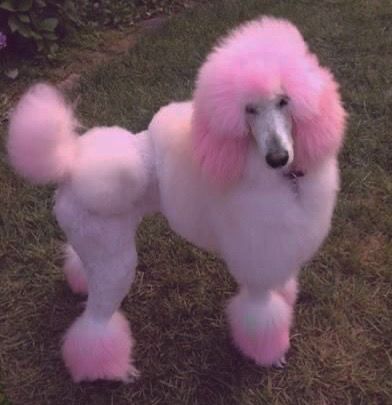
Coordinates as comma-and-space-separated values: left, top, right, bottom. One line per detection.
292, 67, 347, 171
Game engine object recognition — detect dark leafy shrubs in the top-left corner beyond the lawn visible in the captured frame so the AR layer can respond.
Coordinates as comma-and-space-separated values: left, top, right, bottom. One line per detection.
0, 0, 196, 57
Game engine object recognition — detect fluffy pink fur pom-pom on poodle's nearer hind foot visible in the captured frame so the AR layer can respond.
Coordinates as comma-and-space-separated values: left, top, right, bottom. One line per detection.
63, 312, 138, 382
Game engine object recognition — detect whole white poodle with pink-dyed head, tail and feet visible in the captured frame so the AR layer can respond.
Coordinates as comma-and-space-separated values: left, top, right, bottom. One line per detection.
8, 17, 346, 382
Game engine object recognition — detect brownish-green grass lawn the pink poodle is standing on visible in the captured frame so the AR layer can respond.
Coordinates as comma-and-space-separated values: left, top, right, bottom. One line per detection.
0, 0, 392, 405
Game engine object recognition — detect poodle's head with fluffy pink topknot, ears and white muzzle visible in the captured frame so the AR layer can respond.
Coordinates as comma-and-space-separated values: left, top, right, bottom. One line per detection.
192, 17, 346, 183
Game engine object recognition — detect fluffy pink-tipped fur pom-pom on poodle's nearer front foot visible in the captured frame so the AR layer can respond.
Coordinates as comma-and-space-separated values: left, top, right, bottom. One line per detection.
227, 291, 292, 366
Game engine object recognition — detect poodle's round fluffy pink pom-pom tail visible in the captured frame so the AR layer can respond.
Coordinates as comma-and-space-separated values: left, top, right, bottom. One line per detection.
7, 83, 77, 184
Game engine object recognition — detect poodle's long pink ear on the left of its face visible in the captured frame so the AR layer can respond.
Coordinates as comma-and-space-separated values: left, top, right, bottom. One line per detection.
192, 60, 249, 185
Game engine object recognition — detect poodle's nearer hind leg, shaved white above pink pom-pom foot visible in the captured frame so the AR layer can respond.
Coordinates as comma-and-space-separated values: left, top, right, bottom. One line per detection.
55, 192, 139, 382
